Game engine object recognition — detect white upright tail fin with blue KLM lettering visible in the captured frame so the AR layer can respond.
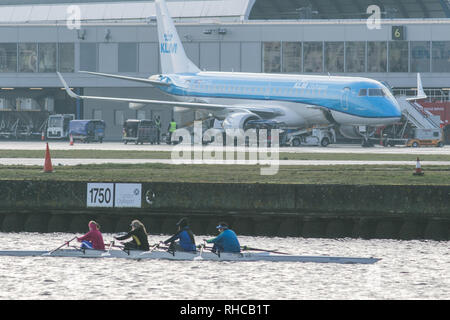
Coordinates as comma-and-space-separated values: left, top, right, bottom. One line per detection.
155, 0, 200, 74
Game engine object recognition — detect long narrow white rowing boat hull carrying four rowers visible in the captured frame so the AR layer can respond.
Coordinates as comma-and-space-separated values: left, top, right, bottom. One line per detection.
0, 249, 381, 264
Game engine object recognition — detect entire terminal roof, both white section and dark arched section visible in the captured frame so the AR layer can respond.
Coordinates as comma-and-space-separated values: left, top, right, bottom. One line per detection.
0, 0, 450, 23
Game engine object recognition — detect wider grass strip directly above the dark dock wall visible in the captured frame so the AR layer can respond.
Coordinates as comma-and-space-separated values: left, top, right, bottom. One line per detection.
0, 164, 450, 185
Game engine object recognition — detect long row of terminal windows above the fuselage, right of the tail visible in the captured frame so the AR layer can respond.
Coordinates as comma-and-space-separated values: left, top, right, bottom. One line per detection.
262, 41, 450, 73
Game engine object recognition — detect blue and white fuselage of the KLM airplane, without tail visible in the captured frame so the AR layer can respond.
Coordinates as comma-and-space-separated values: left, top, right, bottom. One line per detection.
156, 72, 401, 127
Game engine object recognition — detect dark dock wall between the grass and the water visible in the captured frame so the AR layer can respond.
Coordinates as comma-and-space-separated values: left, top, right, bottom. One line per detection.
0, 181, 450, 240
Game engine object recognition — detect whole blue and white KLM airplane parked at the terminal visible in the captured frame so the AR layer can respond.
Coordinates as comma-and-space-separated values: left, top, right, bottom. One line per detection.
58, 0, 401, 144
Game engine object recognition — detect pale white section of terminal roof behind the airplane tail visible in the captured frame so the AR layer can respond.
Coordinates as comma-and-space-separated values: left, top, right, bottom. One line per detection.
0, 0, 255, 23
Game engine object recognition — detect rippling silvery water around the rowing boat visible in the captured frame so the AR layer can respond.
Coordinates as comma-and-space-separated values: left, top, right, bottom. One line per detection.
0, 233, 450, 300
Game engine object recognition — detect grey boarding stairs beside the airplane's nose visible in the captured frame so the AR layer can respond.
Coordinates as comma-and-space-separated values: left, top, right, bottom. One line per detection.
396, 96, 440, 129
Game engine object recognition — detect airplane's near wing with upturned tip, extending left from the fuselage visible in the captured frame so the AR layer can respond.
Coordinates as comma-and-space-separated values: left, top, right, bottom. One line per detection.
57, 72, 282, 118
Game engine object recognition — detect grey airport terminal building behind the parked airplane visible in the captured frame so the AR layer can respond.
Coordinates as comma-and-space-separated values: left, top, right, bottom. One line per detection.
0, 0, 450, 140
